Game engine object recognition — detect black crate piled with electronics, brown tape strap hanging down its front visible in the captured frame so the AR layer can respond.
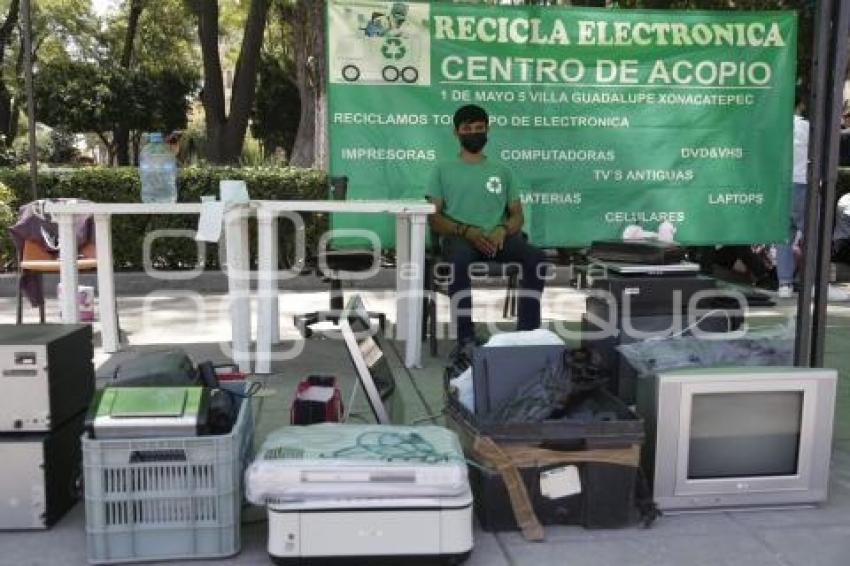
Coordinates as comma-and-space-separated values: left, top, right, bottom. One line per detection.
440, 345, 644, 533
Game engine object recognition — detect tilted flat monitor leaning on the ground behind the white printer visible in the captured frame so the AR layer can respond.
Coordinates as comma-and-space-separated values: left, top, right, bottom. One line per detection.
339, 295, 395, 424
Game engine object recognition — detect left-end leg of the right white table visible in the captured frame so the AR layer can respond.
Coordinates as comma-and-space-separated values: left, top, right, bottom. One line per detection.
255, 208, 280, 373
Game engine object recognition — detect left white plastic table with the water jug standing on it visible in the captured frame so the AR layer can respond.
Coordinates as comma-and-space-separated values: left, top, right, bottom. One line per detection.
45, 202, 251, 372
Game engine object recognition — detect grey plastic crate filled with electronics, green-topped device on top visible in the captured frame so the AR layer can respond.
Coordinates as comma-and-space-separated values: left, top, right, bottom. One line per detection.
82, 350, 253, 564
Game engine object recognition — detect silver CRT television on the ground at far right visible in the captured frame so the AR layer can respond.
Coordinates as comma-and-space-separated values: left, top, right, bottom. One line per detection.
638, 367, 837, 511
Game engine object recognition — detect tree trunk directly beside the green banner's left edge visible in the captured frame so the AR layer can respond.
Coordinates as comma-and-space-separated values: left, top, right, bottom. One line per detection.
290, 0, 327, 167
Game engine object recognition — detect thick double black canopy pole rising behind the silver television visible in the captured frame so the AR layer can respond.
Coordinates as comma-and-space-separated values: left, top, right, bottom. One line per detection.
794, 0, 850, 367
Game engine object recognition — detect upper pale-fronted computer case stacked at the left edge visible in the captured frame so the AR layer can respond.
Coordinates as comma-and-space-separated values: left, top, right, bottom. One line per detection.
0, 324, 94, 432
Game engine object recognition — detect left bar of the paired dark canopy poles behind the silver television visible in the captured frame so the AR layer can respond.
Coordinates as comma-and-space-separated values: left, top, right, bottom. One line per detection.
786, 0, 835, 367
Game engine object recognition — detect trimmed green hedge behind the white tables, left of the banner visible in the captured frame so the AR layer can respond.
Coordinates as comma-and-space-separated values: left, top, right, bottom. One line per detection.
0, 167, 327, 271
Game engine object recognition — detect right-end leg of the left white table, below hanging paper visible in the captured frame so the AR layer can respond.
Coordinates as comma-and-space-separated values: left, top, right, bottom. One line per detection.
224, 207, 251, 373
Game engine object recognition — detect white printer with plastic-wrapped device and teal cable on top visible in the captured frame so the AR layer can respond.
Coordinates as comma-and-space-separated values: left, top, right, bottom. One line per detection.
245, 423, 473, 565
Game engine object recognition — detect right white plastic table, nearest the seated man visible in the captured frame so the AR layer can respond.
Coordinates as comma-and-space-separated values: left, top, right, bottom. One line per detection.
251, 200, 435, 373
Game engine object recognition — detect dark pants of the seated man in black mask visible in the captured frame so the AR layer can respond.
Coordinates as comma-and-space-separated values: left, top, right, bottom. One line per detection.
442, 234, 544, 342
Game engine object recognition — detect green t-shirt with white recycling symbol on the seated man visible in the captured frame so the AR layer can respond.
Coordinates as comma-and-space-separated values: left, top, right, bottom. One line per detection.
428, 157, 519, 232
